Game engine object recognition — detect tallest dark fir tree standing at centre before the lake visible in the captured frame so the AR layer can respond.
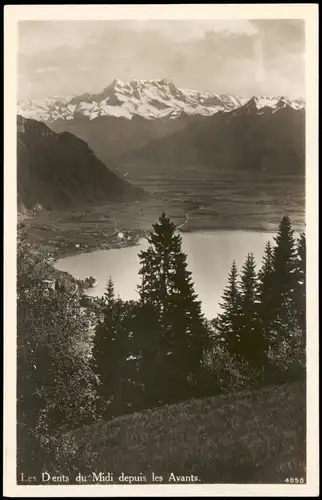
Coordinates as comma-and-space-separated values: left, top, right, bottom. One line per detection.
139, 213, 208, 402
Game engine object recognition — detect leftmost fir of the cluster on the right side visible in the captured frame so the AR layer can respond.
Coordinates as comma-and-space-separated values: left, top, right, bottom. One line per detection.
218, 261, 240, 356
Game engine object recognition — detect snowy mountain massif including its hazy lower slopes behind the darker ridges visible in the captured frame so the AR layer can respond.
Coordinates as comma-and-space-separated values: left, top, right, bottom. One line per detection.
18, 79, 304, 169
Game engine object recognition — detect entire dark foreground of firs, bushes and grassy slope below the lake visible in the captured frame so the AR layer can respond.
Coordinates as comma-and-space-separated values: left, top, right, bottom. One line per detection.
17, 214, 306, 482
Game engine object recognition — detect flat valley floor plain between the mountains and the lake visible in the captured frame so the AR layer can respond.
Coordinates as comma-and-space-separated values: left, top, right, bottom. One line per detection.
20, 171, 305, 258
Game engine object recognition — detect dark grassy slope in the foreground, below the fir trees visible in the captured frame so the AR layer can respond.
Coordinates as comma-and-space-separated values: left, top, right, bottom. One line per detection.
59, 384, 305, 484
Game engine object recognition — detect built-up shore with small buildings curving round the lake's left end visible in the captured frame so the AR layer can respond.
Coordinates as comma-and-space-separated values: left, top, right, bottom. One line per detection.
17, 204, 152, 333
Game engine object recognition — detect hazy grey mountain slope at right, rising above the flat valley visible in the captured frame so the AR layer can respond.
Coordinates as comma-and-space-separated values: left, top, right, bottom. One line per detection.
114, 98, 305, 180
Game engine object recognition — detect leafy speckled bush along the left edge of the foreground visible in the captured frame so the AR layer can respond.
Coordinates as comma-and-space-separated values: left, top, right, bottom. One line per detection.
17, 245, 97, 478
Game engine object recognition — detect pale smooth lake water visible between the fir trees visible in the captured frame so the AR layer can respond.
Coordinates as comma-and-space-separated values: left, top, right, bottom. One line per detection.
55, 230, 275, 319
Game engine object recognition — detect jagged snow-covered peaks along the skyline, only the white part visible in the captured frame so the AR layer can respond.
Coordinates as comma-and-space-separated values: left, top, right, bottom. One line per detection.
17, 79, 305, 123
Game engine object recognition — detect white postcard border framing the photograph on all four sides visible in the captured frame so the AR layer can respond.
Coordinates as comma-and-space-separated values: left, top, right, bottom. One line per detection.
3, 4, 319, 497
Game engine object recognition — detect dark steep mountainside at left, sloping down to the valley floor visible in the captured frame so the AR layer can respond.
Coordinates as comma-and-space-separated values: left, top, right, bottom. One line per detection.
17, 115, 144, 209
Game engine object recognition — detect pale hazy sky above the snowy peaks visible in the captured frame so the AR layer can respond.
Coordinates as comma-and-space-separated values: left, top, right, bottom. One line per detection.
18, 20, 305, 99
